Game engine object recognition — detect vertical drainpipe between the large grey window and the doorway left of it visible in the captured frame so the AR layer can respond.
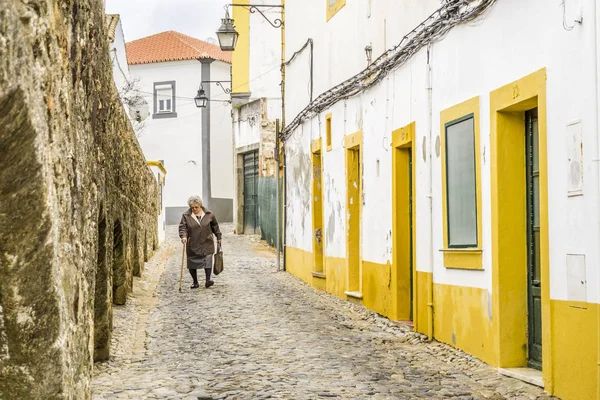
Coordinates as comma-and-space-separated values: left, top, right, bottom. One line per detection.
426, 44, 434, 340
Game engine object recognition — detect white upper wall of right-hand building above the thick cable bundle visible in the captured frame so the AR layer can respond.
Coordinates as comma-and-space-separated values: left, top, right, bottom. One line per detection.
285, 0, 440, 122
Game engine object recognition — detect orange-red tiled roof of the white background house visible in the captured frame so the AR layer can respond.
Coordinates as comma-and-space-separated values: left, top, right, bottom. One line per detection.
126, 31, 231, 65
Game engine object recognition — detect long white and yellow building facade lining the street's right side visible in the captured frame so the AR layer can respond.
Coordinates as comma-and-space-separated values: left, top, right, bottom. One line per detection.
278, 0, 600, 400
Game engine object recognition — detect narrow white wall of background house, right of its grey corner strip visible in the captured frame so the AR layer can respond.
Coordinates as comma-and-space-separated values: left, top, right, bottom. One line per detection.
210, 61, 233, 199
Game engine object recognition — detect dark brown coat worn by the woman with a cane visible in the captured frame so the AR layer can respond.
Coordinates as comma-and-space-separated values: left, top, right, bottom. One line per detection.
179, 207, 221, 257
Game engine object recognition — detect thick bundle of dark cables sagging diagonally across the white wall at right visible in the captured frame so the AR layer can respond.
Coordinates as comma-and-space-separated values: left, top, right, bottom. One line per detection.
281, 0, 497, 142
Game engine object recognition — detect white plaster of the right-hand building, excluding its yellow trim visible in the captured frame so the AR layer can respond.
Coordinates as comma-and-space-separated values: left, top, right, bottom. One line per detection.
286, 0, 599, 302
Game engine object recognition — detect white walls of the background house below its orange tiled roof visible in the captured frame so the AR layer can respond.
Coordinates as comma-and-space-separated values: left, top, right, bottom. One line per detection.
130, 60, 233, 207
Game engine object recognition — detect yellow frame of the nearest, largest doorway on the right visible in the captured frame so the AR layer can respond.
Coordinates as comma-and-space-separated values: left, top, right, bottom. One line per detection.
490, 68, 554, 393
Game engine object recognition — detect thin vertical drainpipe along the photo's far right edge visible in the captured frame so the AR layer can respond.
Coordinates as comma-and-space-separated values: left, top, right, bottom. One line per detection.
592, 1, 600, 400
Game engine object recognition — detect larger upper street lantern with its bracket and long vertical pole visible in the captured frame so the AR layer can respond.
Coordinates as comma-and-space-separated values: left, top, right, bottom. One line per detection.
216, 0, 285, 271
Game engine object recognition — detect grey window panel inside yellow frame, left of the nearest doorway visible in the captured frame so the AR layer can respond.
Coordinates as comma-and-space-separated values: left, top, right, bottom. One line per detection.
445, 114, 478, 248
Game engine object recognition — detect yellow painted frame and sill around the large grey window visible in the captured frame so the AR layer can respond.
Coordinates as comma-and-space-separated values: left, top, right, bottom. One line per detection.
440, 97, 483, 270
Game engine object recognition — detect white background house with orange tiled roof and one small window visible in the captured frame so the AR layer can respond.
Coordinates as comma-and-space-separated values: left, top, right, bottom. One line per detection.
127, 31, 233, 225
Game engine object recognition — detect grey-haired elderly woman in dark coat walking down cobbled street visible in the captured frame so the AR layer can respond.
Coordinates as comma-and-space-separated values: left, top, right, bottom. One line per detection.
179, 196, 221, 289
